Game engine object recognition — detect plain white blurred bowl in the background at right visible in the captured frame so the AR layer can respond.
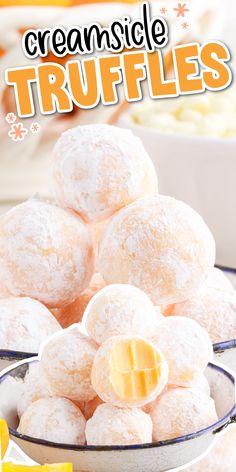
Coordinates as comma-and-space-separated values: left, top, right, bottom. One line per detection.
117, 113, 236, 268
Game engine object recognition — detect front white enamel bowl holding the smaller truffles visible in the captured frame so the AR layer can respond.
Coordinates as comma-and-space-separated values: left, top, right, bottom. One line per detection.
0, 362, 236, 472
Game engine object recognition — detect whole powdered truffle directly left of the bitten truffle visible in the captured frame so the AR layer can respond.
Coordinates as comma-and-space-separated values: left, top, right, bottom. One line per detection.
40, 326, 96, 402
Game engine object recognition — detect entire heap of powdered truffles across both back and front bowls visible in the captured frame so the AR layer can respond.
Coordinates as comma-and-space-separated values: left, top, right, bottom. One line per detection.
0, 125, 236, 445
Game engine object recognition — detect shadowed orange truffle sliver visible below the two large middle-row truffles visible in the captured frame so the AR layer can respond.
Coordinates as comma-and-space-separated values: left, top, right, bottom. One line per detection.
53, 273, 106, 328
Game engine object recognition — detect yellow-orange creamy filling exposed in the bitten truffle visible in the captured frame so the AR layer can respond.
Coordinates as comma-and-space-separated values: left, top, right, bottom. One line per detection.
111, 339, 161, 400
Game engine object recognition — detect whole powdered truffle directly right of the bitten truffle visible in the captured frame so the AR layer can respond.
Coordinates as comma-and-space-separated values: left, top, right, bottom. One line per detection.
152, 316, 213, 386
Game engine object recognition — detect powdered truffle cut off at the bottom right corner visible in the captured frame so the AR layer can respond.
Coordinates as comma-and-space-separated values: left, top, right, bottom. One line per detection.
185, 425, 236, 472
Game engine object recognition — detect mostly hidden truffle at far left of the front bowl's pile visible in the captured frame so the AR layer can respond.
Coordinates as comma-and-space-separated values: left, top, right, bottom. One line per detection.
17, 362, 53, 418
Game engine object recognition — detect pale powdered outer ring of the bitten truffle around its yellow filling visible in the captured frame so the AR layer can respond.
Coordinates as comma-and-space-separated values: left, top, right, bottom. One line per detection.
91, 335, 168, 408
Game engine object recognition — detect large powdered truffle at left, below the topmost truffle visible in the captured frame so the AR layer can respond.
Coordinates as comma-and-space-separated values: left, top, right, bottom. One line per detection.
0, 199, 94, 307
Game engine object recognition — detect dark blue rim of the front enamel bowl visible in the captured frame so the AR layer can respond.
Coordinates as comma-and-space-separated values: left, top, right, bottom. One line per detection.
0, 360, 236, 452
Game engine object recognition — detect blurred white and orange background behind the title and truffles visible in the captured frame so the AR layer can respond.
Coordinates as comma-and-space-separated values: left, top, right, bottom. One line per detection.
0, 0, 236, 268
